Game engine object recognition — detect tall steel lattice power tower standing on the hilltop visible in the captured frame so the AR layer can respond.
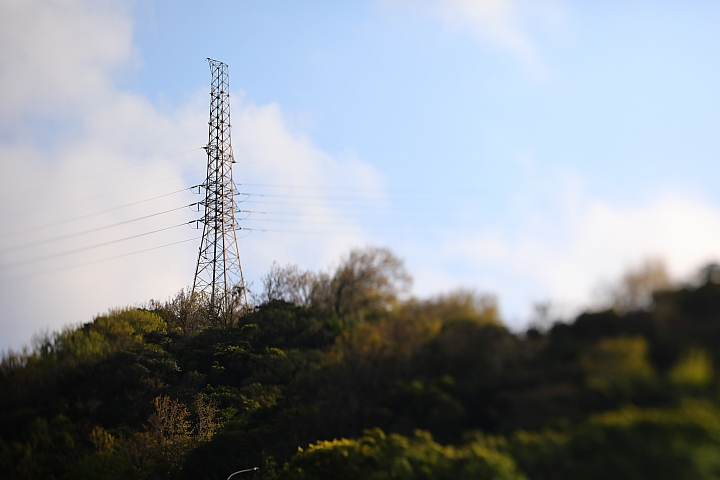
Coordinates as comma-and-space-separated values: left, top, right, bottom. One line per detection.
193, 58, 248, 314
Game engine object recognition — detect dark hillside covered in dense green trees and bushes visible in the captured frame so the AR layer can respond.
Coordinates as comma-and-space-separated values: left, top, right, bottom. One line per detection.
0, 248, 720, 480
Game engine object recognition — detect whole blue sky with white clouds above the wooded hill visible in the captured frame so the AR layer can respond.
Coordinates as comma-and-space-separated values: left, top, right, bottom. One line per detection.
0, 0, 720, 350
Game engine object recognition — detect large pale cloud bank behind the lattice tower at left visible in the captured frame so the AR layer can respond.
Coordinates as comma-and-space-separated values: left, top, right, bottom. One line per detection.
0, 0, 380, 349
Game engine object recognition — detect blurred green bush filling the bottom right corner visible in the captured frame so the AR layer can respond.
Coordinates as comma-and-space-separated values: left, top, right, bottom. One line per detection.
511, 401, 720, 480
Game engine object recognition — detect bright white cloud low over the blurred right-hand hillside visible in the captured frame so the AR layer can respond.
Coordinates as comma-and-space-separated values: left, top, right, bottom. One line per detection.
410, 187, 720, 327
